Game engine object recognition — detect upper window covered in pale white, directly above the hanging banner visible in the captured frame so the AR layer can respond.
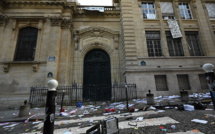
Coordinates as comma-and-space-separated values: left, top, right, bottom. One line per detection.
160, 2, 175, 19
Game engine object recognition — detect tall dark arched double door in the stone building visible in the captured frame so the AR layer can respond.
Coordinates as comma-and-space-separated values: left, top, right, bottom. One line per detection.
83, 49, 111, 101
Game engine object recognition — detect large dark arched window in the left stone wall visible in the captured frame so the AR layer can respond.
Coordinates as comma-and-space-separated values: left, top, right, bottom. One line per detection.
14, 27, 38, 61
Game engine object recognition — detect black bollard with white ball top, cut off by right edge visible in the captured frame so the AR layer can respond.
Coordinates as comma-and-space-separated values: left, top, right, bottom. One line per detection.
202, 63, 215, 109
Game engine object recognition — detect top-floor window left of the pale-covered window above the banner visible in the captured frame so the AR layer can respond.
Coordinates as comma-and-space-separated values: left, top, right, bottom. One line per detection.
142, 2, 156, 19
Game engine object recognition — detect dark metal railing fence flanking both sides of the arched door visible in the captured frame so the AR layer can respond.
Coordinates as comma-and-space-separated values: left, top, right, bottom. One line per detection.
29, 83, 137, 107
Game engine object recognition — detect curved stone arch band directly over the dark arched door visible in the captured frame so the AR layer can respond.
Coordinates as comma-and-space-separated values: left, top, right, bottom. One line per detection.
80, 42, 113, 58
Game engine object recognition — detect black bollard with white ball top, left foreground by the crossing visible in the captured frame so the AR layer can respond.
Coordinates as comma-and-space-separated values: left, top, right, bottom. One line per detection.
43, 79, 58, 134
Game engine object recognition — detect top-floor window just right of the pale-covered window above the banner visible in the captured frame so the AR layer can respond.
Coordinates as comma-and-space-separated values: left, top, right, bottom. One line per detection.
179, 3, 192, 19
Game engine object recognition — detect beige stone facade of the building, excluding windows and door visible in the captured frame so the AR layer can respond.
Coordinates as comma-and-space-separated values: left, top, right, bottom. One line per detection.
0, 0, 215, 105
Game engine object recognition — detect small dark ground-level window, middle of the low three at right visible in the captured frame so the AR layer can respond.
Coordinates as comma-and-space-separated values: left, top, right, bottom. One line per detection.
177, 74, 191, 90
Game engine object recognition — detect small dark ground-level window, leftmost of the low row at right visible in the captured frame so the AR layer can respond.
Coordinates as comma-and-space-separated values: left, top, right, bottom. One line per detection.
155, 75, 168, 91
